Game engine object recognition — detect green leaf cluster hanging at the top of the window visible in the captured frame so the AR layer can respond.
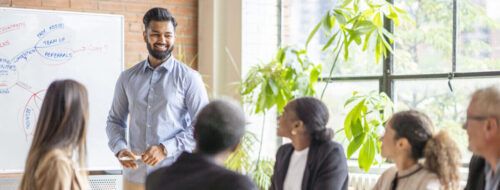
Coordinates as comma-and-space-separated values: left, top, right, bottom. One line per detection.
306, 0, 406, 65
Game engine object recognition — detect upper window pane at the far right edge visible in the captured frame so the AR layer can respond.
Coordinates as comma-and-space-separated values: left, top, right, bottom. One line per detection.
457, 0, 500, 72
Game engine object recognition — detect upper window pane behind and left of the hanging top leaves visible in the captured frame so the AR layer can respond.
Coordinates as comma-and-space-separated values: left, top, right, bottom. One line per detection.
281, 0, 382, 77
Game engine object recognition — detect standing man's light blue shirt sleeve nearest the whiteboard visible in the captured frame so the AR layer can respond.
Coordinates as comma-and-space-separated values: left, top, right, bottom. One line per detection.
106, 72, 129, 155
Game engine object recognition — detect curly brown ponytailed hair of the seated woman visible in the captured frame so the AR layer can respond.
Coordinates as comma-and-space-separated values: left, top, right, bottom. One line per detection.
389, 110, 460, 189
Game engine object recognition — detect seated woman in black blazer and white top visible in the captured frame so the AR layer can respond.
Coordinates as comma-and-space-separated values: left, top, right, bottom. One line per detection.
270, 97, 348, 190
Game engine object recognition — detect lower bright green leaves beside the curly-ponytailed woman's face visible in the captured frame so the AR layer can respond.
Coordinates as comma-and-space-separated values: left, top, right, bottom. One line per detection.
344, 92, 393, 171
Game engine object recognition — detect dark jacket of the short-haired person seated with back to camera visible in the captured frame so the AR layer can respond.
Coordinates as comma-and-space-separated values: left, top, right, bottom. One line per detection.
146, 152, 257, 190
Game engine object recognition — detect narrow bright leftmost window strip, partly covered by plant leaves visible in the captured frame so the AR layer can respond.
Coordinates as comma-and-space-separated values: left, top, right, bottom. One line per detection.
240, 0, 279, 159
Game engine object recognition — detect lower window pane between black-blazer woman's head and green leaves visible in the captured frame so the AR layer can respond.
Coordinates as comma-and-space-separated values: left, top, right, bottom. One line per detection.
316, 81, 379, 155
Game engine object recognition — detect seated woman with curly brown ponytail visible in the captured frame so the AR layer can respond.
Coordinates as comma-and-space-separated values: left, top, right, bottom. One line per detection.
373, 110, 460, 190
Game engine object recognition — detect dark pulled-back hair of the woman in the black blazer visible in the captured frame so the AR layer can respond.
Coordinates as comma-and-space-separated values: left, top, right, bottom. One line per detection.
293, 97, 333, 142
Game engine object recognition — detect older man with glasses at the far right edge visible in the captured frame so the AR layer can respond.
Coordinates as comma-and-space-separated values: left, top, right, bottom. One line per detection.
464, 86, 500, 190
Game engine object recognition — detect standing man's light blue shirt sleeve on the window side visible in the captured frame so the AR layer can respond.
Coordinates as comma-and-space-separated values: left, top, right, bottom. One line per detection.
162, 72, 208, 157
